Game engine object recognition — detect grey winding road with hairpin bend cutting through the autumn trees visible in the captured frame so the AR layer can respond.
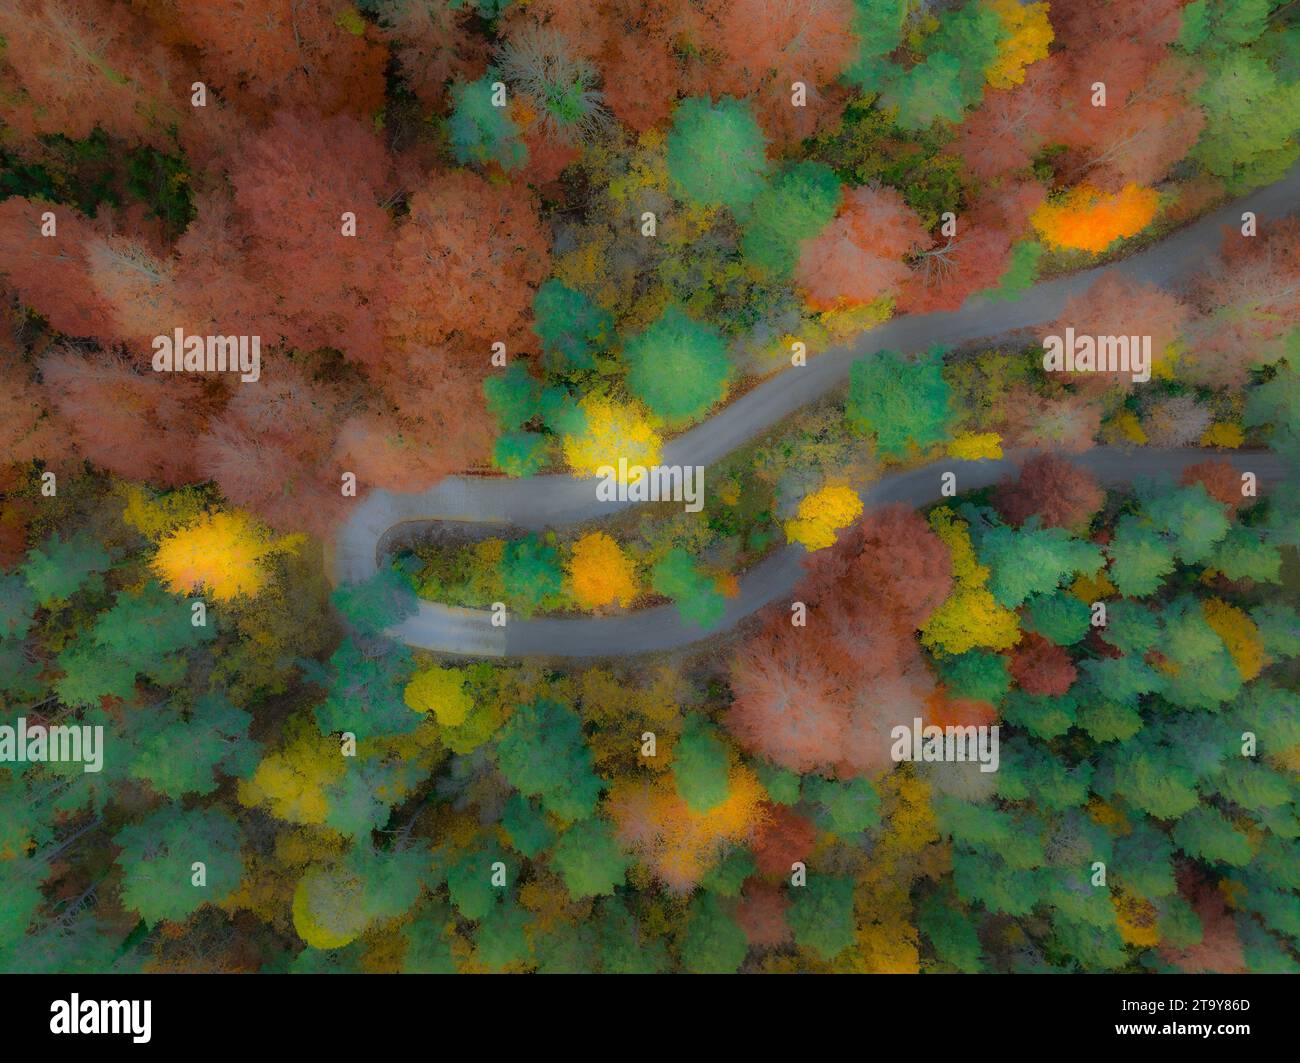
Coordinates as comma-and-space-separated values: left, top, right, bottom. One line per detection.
330, 165, 1300, 658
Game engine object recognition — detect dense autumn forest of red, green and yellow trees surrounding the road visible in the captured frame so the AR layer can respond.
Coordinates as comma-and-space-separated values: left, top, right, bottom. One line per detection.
0, 0, 1300, 973
